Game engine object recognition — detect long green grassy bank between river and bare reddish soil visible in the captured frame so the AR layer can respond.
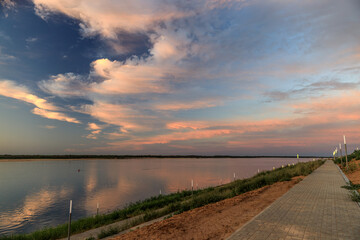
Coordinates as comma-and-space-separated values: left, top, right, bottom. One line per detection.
0, 160, 324, 240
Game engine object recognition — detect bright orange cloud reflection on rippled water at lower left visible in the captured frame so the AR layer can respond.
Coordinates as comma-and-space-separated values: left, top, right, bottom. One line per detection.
0, 187, 73, 234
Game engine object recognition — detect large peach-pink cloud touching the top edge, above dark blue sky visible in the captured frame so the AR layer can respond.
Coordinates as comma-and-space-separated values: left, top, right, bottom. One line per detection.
33, 0, 192, 38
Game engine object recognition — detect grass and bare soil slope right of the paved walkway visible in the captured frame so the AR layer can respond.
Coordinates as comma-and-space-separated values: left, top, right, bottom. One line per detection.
334, 150, 360, 202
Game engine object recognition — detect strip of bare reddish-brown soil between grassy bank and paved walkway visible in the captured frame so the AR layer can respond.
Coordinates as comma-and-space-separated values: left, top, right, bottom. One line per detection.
111, 177, 303, 240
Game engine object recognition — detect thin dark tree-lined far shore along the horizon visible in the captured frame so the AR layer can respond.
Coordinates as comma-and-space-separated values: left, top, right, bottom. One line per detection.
0, 154, 327, 162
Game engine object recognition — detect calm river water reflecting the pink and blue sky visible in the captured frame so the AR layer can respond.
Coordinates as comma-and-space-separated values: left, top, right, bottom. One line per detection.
0, 158, 312, 235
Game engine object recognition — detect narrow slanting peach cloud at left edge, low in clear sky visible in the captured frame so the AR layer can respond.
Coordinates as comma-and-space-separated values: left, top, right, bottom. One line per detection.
0, 80, 80, 123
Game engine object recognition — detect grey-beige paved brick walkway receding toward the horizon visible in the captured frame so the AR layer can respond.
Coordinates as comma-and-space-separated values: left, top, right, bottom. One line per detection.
228, 161, 360, 240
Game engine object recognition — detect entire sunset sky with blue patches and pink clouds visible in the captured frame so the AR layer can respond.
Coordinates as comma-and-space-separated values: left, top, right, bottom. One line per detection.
0, 0, 360, 156
